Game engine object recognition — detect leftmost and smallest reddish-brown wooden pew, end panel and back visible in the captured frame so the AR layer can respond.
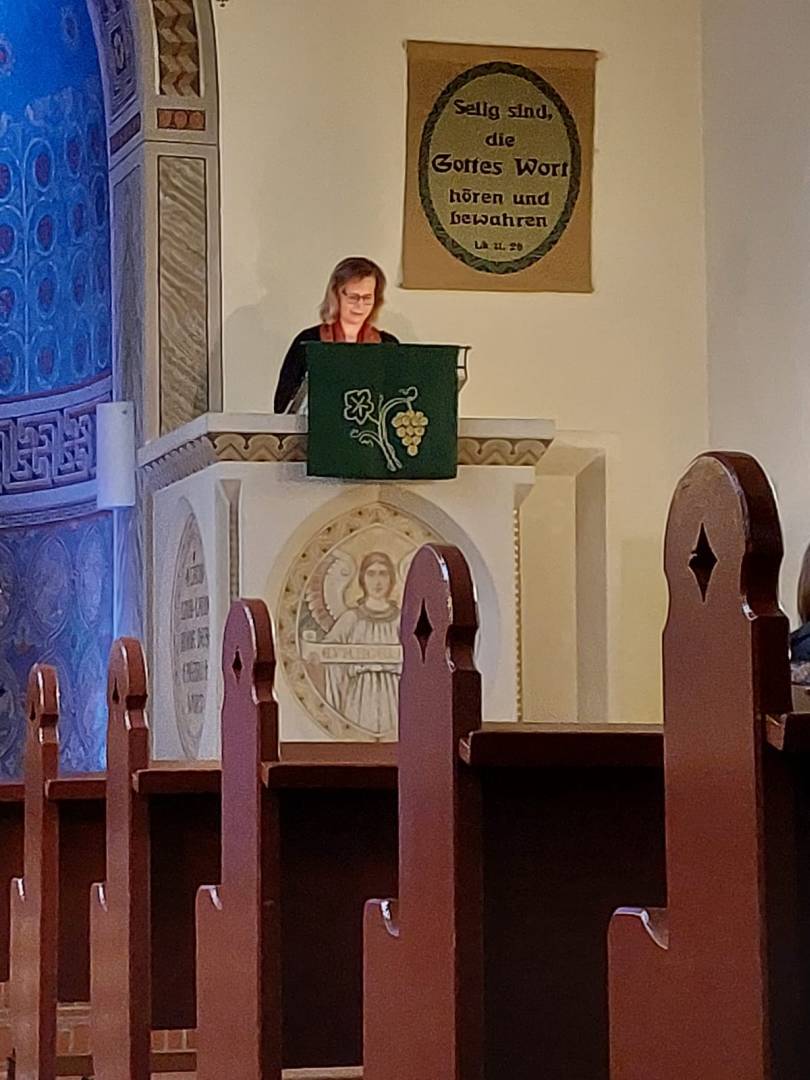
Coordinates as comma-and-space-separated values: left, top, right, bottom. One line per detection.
10, 664, 105, 1080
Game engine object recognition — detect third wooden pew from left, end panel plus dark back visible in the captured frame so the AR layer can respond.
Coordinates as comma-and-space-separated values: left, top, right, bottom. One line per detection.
197, 600, 396, 1080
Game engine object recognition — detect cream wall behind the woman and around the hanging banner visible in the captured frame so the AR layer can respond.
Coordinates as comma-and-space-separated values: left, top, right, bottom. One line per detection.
212, 0, 707, 720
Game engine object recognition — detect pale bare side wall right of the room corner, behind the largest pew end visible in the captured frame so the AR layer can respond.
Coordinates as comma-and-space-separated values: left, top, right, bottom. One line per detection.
704, 0, 810, 616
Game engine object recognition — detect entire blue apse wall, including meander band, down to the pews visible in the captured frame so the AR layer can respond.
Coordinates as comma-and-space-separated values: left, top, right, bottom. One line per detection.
0, 0, 113, 777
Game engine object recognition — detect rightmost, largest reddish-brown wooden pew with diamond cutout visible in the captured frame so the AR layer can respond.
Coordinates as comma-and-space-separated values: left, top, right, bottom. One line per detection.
609, 454, 810, 1080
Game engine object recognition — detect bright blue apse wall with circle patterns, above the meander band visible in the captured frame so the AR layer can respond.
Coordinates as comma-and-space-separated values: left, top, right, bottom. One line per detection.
0, 0, 111, 400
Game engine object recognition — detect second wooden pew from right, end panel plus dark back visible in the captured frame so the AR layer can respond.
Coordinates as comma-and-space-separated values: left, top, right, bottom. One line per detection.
364, 546, 664, 1080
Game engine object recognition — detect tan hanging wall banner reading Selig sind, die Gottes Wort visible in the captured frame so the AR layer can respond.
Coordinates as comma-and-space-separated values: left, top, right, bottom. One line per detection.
402, 41, 596, 293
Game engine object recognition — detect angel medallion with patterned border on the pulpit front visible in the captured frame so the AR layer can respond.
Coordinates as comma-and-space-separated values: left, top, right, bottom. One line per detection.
279, 503, 438, 740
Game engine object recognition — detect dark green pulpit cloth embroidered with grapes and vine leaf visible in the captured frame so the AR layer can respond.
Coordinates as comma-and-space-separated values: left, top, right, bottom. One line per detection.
306, 342, 458, 481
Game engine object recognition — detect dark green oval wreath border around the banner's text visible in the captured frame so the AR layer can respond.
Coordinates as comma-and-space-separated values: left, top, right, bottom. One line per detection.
418, 60, 582, 274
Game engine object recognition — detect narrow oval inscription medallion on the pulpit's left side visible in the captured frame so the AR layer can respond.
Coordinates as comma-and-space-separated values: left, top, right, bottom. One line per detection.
172, 509, 210, 758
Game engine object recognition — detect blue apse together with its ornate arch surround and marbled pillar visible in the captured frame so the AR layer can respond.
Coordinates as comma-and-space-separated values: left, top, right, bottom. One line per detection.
0, 0, 221, 778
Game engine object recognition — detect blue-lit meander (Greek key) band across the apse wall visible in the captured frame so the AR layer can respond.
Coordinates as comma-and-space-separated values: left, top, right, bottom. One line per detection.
0, 394, 102, 495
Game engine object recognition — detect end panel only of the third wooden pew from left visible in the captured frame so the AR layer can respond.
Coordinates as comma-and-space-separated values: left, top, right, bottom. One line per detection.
197, 599, 282, 1080
